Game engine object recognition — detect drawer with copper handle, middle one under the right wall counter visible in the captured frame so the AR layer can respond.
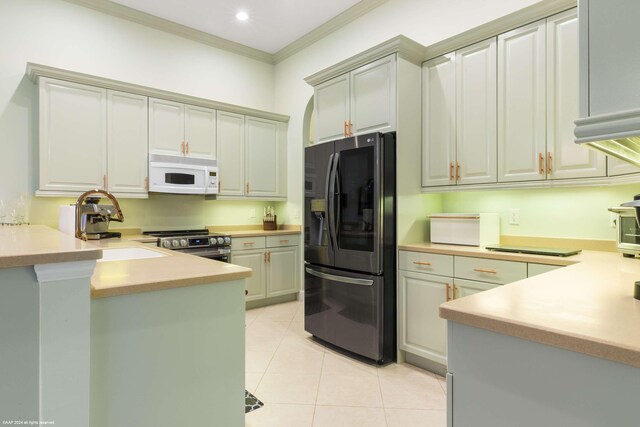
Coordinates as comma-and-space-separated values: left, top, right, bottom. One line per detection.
454, 256, 527, 284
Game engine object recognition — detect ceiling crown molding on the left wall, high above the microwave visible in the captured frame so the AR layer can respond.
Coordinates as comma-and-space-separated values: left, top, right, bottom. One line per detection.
65, 0, 273, 64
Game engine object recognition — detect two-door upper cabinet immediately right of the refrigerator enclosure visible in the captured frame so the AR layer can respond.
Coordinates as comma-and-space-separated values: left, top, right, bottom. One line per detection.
422, 38, 496, 187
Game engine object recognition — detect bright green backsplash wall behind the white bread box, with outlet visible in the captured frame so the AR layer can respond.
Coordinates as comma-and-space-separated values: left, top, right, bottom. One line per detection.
442, 184, 640, 240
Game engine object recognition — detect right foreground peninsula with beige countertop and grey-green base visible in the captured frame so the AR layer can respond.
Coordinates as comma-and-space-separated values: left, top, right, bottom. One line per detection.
440, 246, 640, 427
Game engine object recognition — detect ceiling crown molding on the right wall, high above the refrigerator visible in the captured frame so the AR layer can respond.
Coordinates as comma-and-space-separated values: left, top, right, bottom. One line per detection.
273, 0, 388, 64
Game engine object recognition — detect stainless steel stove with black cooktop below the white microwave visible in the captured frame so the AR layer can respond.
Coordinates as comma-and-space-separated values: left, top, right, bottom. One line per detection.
142, 228, 231, 262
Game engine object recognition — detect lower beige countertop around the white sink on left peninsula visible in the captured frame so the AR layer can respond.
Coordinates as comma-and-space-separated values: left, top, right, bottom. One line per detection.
91, 239, 252, 298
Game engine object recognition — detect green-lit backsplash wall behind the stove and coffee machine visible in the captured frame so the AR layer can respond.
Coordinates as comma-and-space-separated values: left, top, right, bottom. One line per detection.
29, 194, 283, 230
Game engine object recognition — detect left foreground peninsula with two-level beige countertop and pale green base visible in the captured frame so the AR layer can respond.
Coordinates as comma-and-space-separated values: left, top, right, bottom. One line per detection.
0, 226, 251, 427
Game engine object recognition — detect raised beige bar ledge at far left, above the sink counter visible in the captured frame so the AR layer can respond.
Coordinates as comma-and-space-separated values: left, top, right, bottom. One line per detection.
0, 225, 102, 268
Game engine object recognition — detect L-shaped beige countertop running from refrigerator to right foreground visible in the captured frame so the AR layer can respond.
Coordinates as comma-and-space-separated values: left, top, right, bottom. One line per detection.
400, 244, 640, 367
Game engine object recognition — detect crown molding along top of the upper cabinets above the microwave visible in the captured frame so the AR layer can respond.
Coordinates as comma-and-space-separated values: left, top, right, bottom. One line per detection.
26, 62, 289, 123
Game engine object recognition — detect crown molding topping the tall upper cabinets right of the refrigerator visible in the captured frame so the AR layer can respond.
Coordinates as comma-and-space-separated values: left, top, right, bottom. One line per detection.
424, 0, 577, 61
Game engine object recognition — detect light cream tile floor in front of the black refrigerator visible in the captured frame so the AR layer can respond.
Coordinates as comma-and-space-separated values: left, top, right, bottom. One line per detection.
245, 301, 446, 427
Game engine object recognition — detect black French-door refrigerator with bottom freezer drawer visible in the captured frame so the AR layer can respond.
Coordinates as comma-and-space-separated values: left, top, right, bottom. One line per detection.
304, 132, 396, 364
